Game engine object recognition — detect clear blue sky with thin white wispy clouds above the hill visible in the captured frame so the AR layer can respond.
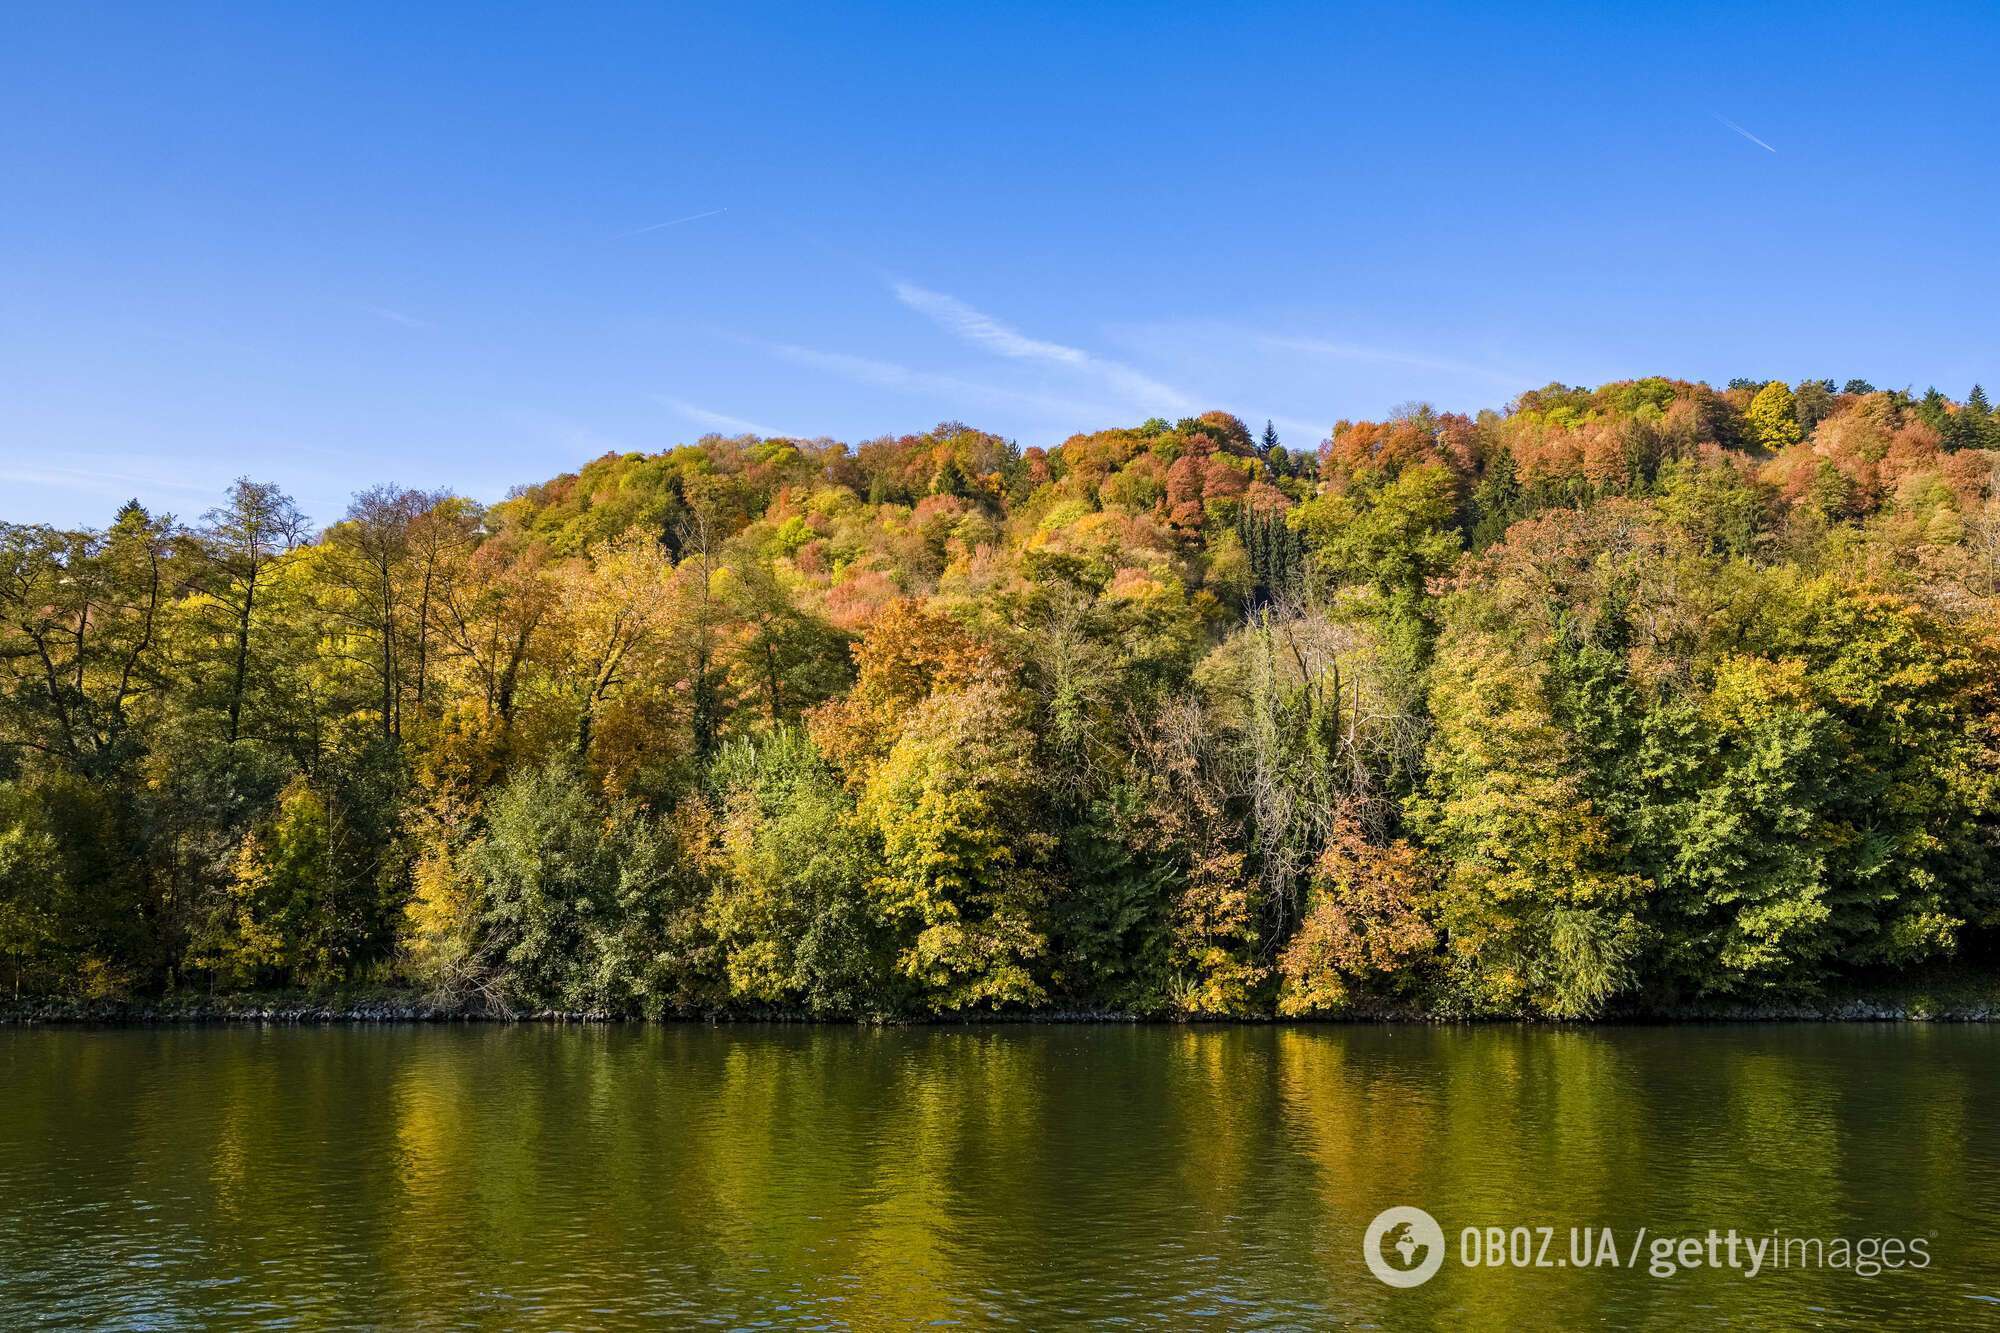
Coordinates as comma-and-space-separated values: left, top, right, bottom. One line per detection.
0, 2, 2000, 522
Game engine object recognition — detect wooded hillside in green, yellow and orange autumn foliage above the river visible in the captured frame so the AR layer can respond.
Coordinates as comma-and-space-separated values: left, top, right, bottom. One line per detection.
0, 378, 2000, 1017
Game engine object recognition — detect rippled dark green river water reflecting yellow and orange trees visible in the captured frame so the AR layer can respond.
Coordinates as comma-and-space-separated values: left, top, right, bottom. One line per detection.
0, 1025, 2000, 1329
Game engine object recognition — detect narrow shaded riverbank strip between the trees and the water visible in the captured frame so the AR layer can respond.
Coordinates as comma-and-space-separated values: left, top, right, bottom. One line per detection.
0, 969, 2000, 1025
